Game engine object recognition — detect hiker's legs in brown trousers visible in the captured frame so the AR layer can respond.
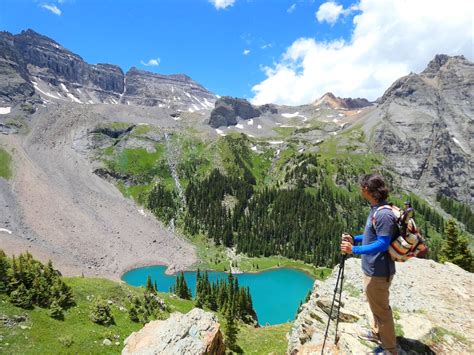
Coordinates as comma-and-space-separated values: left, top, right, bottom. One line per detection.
365, 277, 397, 354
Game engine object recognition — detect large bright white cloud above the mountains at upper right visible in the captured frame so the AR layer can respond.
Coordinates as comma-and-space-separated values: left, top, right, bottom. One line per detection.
252, 0, 474, 105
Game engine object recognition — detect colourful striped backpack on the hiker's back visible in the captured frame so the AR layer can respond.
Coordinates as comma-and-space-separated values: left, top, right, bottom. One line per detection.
372, 204, 428, 262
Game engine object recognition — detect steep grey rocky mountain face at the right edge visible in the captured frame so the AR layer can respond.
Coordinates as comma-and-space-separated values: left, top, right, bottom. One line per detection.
372, 55, 474, 204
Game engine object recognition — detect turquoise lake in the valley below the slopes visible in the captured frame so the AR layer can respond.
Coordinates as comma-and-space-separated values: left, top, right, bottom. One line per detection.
122, 266, 314, 326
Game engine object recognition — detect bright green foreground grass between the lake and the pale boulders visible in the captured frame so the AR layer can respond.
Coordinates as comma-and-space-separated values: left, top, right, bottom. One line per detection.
0, 277, 291, 354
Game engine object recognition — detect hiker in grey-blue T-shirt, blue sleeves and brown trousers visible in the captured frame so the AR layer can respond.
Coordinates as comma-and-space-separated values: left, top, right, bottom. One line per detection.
341, 174, 399, 354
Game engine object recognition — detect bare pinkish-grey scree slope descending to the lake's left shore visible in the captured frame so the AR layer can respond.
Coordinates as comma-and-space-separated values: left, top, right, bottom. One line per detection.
0, 105, 197, 279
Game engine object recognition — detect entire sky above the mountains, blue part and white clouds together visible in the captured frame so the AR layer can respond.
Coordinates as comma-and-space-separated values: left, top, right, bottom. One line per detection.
0, 0, 474, 104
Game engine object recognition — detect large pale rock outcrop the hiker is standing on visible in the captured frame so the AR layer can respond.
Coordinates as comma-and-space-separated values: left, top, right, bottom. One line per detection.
288, 258, 474, 354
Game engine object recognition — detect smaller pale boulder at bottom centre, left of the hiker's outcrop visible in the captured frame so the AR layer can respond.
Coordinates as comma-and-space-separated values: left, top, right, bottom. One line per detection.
122, 308, 225, 355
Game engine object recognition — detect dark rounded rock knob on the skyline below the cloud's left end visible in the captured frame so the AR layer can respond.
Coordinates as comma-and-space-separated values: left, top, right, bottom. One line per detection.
209, 96, 262, 128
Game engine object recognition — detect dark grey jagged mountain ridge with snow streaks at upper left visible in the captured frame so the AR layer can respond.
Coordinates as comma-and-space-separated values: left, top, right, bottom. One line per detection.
0, 29, 215, 112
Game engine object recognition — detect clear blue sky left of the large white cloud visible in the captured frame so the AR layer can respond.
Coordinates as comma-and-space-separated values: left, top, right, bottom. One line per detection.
0, 0, 356, 97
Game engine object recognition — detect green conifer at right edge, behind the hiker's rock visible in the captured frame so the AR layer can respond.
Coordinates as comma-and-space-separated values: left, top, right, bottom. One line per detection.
440, 219, 474, 272
